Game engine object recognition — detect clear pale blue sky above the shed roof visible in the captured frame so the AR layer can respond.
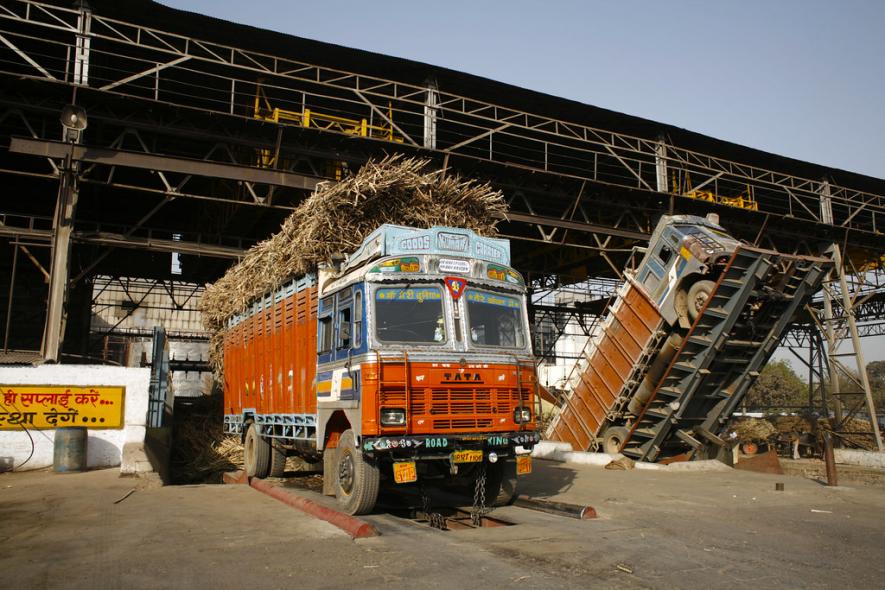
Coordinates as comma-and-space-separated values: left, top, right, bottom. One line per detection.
162, 0, 885, 178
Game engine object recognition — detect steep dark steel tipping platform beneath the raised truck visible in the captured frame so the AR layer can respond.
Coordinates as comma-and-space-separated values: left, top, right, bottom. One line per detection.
621, 246, 831, 461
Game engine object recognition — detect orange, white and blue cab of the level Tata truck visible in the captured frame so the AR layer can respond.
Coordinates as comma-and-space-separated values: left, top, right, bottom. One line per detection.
316, 225, 538, 512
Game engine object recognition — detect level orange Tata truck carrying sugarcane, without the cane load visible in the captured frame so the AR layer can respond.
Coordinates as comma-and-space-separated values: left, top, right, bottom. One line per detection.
223, 225, 538, 514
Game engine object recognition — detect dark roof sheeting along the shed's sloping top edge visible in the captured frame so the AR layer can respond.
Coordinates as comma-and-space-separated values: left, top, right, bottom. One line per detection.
53, 0, 885, 195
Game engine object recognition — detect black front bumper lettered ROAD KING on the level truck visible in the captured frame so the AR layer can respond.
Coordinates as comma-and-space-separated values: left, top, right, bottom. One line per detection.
361, 432, 541, 459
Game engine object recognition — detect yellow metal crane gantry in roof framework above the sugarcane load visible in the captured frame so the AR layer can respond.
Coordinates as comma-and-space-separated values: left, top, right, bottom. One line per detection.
253, 82, 403, 170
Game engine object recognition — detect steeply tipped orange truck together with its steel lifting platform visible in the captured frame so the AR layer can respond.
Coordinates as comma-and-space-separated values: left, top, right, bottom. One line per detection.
546, 215, 832, 461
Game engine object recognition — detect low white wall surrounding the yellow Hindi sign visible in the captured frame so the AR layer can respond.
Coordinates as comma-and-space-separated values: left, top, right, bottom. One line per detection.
0, 365, 150, 471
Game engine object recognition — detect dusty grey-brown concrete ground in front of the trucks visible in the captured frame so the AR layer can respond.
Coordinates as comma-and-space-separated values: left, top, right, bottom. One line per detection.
0, 461, 885, 590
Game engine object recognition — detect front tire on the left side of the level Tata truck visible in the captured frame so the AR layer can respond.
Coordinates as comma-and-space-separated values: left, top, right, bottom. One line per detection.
335, 430, 379, 514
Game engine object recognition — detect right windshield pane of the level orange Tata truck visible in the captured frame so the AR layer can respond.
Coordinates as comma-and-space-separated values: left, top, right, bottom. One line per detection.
465, 289, 525, 348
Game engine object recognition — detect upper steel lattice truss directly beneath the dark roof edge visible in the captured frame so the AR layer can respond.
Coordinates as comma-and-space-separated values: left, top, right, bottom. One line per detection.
0, 1, 885, 247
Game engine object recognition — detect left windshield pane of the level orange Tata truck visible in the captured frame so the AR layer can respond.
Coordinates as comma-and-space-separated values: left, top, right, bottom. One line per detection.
375, 285, 446, 344
